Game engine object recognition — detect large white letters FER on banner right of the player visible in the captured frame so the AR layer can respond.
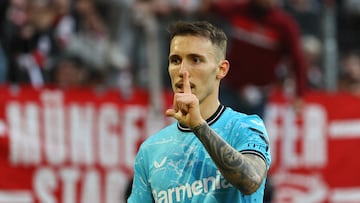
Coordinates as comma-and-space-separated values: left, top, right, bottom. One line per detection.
265, 104, 328, 169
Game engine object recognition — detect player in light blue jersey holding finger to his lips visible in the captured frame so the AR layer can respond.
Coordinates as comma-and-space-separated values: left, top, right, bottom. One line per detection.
128, 21, 271, 203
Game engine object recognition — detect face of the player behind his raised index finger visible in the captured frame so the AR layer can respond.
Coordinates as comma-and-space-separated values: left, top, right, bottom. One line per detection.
168, 35, 220, 103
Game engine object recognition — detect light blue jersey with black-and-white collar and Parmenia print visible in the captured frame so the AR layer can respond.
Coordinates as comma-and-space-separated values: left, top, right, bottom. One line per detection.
128, 106, 271, 203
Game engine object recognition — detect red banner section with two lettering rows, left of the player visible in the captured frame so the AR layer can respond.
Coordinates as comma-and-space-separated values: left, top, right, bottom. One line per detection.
0, 87, 173, 203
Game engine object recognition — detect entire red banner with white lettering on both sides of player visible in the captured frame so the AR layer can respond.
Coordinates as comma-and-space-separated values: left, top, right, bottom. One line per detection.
0, 86, 360, 203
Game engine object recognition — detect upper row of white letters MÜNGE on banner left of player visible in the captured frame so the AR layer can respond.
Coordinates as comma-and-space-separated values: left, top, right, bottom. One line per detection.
6, 90, 156, 168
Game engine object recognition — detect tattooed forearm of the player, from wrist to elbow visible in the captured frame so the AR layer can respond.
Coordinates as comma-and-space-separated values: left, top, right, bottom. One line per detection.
193, 123, 266, 194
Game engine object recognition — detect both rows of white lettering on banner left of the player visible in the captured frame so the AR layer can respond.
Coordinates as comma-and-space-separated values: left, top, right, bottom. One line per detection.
6, 91, 166, 203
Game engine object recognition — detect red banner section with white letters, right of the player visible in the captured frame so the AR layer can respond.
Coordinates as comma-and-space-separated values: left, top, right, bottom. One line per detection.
266, 92, 360, 203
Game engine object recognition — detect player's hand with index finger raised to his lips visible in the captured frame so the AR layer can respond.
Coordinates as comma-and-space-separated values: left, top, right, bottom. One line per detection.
165, 71, 205, 128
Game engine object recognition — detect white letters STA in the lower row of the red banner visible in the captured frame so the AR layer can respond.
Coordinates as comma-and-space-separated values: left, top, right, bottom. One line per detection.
33, 167, 128, 203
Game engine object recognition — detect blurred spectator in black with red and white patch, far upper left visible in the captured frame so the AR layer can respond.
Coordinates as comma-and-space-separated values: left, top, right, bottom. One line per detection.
4, 0, 58, 87
